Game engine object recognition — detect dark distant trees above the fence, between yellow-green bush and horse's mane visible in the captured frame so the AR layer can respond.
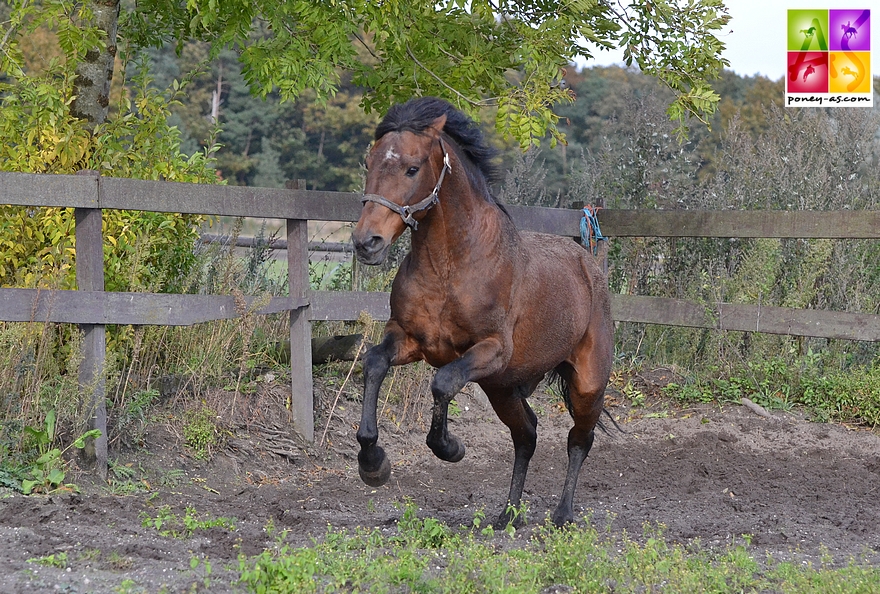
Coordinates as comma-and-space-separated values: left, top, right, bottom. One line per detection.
150, 42, 378, 191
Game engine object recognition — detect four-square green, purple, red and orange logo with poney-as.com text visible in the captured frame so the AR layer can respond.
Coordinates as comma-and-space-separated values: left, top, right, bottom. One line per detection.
785, 9, 874, 107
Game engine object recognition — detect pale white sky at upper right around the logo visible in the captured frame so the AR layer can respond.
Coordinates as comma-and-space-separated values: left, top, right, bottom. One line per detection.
587, 0, 880, 80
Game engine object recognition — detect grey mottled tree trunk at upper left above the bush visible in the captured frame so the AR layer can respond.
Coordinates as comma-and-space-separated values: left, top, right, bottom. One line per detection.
71, 0, 119, 130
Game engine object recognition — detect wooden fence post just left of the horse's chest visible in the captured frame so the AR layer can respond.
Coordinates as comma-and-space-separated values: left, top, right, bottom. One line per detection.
287, 180, 315, 442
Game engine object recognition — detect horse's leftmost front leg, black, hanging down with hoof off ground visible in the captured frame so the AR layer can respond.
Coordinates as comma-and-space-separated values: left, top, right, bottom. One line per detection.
357, 322, 418, 487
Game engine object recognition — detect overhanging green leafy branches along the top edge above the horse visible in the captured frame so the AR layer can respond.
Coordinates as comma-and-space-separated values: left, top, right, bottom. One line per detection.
121, 0, 729, 148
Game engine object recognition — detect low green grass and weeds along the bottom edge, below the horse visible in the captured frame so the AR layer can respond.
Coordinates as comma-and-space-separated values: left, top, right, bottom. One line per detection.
239, 504, 880, 594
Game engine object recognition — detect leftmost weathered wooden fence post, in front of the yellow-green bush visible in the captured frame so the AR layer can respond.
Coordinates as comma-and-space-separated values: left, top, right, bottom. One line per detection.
74, 171, 107, 480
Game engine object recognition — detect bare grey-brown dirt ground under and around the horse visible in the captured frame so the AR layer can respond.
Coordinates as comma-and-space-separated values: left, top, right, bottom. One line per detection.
0, 370, 880, 592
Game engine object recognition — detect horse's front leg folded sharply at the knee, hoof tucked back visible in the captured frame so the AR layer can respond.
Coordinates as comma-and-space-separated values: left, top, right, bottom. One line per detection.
426, 338, 510, 462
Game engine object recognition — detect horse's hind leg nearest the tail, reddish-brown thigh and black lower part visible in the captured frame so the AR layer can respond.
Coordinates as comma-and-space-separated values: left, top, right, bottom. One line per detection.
553, 333, 613, 526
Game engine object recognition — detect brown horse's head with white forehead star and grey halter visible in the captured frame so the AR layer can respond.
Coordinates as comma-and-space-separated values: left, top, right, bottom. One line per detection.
351, 115, 448, 264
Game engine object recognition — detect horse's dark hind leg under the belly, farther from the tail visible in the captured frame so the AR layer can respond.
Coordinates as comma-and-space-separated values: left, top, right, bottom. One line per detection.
486, 378, 540, 528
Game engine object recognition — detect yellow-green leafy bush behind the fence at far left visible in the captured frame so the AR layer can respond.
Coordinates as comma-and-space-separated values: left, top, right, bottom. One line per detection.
0, 52, 218, 291
